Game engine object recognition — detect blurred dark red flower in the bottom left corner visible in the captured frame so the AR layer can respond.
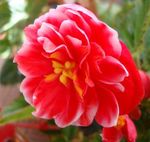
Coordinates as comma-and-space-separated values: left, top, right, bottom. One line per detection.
0, 124, 15, 142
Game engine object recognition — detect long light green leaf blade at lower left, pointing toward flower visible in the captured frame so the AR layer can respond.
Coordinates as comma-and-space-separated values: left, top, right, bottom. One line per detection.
0, 106, 33, 125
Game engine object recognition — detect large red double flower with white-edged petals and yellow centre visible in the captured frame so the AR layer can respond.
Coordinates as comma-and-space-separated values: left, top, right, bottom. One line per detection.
15, 4, 143, 127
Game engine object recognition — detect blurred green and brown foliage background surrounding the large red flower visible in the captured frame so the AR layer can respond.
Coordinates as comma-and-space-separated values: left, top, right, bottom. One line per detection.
0, 0, 150, 142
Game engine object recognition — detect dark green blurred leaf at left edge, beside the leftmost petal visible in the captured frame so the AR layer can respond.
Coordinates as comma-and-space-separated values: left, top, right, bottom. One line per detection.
0, 58, 23, 85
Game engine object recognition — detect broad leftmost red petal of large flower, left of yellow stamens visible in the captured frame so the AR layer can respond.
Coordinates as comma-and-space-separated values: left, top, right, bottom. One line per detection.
14, 42, 52, 77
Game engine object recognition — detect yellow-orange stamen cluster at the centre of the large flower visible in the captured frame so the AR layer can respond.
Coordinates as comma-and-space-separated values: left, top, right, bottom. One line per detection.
45, 52, 84, 98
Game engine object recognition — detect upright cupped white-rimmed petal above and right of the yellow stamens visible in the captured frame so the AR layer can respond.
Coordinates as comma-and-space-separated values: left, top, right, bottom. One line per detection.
59, 20, 90, 66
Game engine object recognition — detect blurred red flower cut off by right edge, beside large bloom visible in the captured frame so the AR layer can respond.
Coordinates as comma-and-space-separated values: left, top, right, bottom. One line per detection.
139, 71, 150, 99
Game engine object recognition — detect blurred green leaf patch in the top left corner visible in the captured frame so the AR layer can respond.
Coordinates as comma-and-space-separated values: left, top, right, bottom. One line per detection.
0, 0, 11, 28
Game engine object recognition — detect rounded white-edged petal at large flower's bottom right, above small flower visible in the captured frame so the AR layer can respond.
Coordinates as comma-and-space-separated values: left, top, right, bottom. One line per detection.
96, 88, 119, 127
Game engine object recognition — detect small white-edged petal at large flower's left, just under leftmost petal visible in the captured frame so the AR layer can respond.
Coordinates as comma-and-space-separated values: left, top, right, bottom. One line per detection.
20, 77, 42, 105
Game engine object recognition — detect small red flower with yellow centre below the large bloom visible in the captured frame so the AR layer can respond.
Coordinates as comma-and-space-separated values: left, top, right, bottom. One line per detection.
102, 115, 137, 142
